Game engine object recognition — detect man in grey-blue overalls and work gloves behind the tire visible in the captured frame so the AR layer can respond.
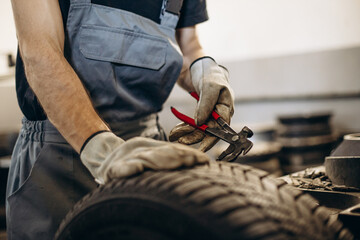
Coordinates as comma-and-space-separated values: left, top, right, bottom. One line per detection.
7, 0, 233, 240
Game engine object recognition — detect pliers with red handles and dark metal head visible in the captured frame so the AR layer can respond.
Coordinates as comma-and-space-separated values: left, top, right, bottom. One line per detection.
171, 92, 253, 162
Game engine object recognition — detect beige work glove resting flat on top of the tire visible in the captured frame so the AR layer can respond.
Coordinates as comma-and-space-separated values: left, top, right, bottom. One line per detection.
80, 132, 209, 184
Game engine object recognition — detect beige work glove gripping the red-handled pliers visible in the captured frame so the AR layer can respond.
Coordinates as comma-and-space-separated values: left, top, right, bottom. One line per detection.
169, 57, 234, 152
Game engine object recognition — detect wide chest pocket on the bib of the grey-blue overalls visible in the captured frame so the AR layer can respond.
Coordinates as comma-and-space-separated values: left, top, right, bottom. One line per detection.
80, 25, 168, 70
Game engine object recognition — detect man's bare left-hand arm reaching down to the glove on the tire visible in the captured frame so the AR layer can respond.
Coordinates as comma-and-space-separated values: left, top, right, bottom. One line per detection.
11, 0, 108, 152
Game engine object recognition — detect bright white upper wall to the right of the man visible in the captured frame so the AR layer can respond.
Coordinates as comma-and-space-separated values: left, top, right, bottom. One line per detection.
199, 0, 360, 60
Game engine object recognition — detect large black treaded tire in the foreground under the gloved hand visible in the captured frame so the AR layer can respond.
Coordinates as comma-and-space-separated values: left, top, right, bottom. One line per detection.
55, 162, 353, 240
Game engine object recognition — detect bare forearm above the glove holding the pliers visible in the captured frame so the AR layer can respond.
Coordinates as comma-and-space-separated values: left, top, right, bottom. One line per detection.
176, 26, 205, 92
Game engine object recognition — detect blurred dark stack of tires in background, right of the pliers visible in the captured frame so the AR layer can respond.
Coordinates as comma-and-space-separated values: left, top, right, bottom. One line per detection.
277, 112, 336, 174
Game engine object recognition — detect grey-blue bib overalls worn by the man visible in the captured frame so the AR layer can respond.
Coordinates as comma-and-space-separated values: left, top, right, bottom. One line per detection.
6, 0, 182, 240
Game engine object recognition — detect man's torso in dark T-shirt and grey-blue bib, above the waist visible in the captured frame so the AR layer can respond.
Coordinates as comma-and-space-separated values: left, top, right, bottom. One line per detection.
17, 0, 207, 122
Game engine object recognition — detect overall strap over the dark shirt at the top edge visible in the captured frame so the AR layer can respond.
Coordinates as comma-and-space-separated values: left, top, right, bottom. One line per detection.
160, 0, 183, 28
